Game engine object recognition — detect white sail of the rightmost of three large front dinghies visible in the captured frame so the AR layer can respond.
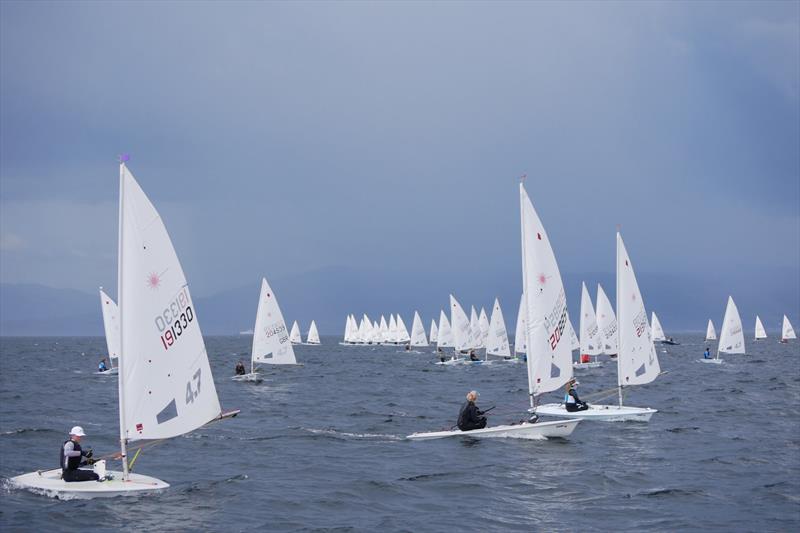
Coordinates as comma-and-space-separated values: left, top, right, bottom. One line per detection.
617, 232, 661, 387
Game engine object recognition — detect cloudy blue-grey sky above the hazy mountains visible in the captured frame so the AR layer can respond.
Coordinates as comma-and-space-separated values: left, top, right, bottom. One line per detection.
0, 1, 800, 332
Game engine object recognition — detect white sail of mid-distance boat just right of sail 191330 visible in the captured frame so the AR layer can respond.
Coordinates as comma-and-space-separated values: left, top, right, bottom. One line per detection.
252, 278, 297, 365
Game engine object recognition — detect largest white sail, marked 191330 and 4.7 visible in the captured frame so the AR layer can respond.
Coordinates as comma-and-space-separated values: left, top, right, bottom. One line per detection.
118, 164, 221, 441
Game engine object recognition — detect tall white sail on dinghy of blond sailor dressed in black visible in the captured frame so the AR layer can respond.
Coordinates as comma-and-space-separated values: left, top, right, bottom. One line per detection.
519, 183, 572, 394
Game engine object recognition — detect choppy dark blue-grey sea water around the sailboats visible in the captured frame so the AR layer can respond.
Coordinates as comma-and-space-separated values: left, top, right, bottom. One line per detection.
0, 335, 800, 531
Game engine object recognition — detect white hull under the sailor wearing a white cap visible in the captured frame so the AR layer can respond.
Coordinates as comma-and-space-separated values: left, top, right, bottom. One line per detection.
9, 468, 169, 500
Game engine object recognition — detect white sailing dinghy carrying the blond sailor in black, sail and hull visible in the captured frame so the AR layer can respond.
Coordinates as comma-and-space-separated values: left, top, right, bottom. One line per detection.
408, 183, 580, 440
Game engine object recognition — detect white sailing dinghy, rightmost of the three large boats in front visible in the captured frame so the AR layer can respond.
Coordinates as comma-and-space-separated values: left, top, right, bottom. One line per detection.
537, 232, 661, 422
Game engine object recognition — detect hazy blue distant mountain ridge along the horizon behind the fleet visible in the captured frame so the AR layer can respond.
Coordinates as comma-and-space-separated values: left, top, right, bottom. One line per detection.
0, 266, 800, 337
